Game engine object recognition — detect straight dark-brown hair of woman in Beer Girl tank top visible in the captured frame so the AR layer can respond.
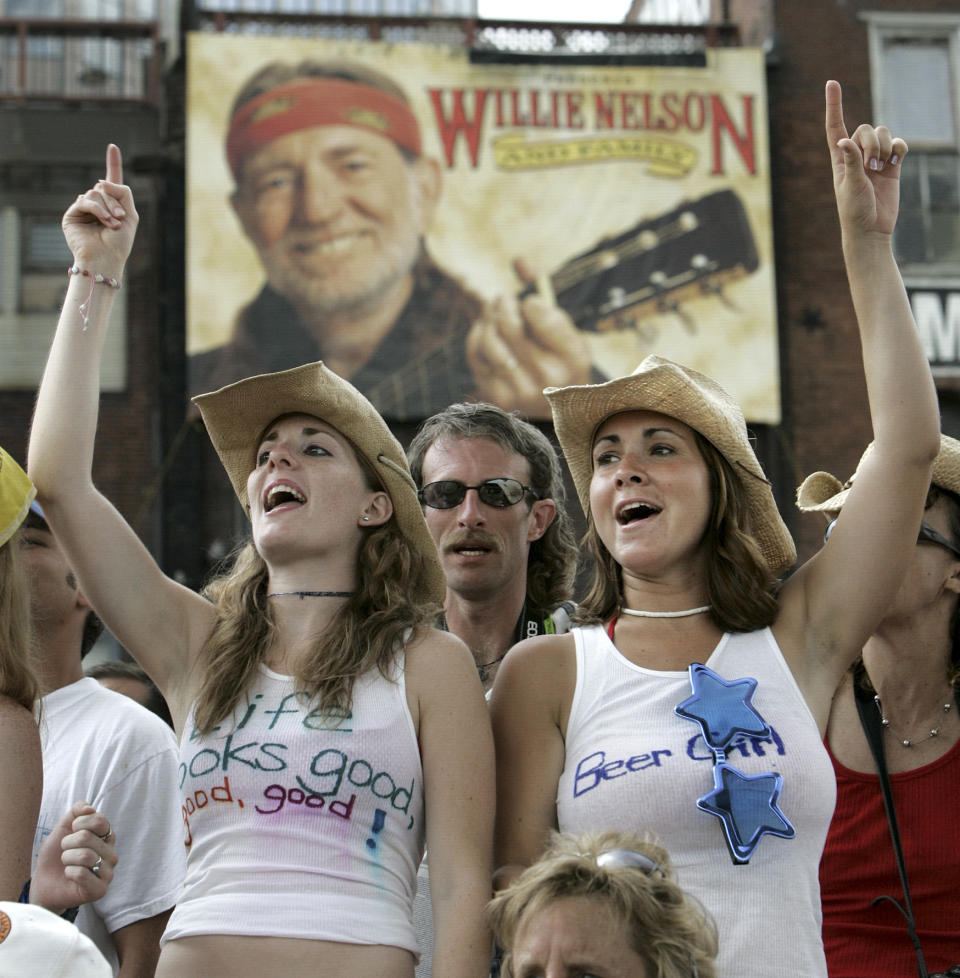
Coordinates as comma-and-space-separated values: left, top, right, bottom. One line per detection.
576, 431, 779, 632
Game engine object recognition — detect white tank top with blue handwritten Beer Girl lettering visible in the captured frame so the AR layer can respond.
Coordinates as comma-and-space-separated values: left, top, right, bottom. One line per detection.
557, 626, 836, 978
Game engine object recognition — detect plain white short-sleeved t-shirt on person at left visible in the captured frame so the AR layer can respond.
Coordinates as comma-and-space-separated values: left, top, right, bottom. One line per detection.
33, 678, 186, 974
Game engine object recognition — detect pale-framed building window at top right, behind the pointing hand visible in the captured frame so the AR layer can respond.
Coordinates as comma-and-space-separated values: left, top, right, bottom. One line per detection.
864, 13, 960, 275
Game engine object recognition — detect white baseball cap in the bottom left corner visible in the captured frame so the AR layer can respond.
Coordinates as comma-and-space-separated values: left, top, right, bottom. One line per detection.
0, 901, 113, 978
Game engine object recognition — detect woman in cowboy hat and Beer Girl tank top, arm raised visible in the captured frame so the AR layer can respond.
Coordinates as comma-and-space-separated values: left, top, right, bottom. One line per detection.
491, 82, 939, 978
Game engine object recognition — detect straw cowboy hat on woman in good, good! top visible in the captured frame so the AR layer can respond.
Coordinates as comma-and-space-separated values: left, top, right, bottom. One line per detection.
193, 360, 446, 602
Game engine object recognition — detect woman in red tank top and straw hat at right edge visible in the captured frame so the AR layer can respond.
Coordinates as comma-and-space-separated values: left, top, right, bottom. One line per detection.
797, 435, 960, 978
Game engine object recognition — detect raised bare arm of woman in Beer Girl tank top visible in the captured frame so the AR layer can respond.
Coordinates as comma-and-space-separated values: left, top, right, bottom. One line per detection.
775, 81, 940, 724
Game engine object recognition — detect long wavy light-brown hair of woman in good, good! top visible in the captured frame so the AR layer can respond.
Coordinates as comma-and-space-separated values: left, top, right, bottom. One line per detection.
194, 448, 440, 734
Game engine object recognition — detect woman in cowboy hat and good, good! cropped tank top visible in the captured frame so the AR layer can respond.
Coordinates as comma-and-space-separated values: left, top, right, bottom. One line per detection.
30, 146, 493, 978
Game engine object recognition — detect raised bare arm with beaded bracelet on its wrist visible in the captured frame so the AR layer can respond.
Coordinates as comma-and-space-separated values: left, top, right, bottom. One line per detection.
29, 145, 212, 706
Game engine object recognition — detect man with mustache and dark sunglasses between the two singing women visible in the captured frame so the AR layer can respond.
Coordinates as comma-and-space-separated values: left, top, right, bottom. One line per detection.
407, 403, 577, 690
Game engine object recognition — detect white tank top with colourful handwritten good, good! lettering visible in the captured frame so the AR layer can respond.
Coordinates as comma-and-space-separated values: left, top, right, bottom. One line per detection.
164, 660, 424, 954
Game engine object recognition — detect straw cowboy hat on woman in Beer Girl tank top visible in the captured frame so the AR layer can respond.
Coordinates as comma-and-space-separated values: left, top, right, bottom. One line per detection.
544, 356, 797, 574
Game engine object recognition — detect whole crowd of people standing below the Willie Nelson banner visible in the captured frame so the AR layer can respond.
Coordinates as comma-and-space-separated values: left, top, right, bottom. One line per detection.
0, 79, 960, 978
